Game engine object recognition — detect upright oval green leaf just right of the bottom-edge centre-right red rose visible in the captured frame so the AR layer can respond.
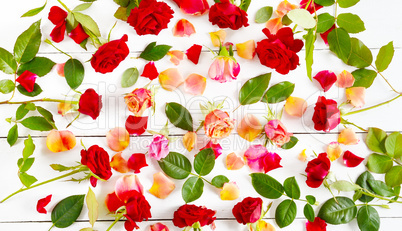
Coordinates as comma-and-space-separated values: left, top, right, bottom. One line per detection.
275, 199, 297, 228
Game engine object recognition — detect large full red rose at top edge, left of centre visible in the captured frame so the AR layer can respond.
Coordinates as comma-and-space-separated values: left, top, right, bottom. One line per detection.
127, 0, 174, 35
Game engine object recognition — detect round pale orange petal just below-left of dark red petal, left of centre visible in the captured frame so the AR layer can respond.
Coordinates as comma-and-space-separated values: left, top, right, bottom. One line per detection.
106, 127, 130, 152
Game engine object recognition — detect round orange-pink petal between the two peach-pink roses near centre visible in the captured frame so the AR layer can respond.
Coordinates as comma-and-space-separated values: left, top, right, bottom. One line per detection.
237, 114, 262, 142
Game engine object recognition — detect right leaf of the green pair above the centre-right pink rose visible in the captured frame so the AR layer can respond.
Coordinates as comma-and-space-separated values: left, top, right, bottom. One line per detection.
261, 81, 295, 103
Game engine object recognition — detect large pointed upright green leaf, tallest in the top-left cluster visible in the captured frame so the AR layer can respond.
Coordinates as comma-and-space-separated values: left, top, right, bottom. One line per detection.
14, 20, 42, 63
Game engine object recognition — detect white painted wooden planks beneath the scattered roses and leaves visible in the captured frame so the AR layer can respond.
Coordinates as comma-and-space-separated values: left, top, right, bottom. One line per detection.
0, 0, 402, 231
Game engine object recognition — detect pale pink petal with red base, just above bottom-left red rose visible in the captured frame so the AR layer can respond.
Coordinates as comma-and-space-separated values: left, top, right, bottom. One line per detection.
115, 174, 144, 202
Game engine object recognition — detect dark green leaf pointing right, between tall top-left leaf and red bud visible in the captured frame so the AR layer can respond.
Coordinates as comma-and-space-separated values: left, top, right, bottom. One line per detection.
17, 57, 56, 77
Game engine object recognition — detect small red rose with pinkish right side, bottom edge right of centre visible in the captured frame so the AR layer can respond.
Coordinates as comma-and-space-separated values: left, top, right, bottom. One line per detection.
232, 197, 262, 225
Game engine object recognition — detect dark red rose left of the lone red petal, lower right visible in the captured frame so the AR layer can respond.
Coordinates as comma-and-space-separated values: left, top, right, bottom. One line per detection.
306, 152, 331, 188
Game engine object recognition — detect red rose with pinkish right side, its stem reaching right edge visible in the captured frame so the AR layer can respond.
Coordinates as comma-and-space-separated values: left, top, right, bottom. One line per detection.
313, 96, 341, 132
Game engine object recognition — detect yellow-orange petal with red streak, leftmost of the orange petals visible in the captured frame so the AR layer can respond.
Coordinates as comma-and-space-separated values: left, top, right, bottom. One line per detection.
46, 130, 76, 152
